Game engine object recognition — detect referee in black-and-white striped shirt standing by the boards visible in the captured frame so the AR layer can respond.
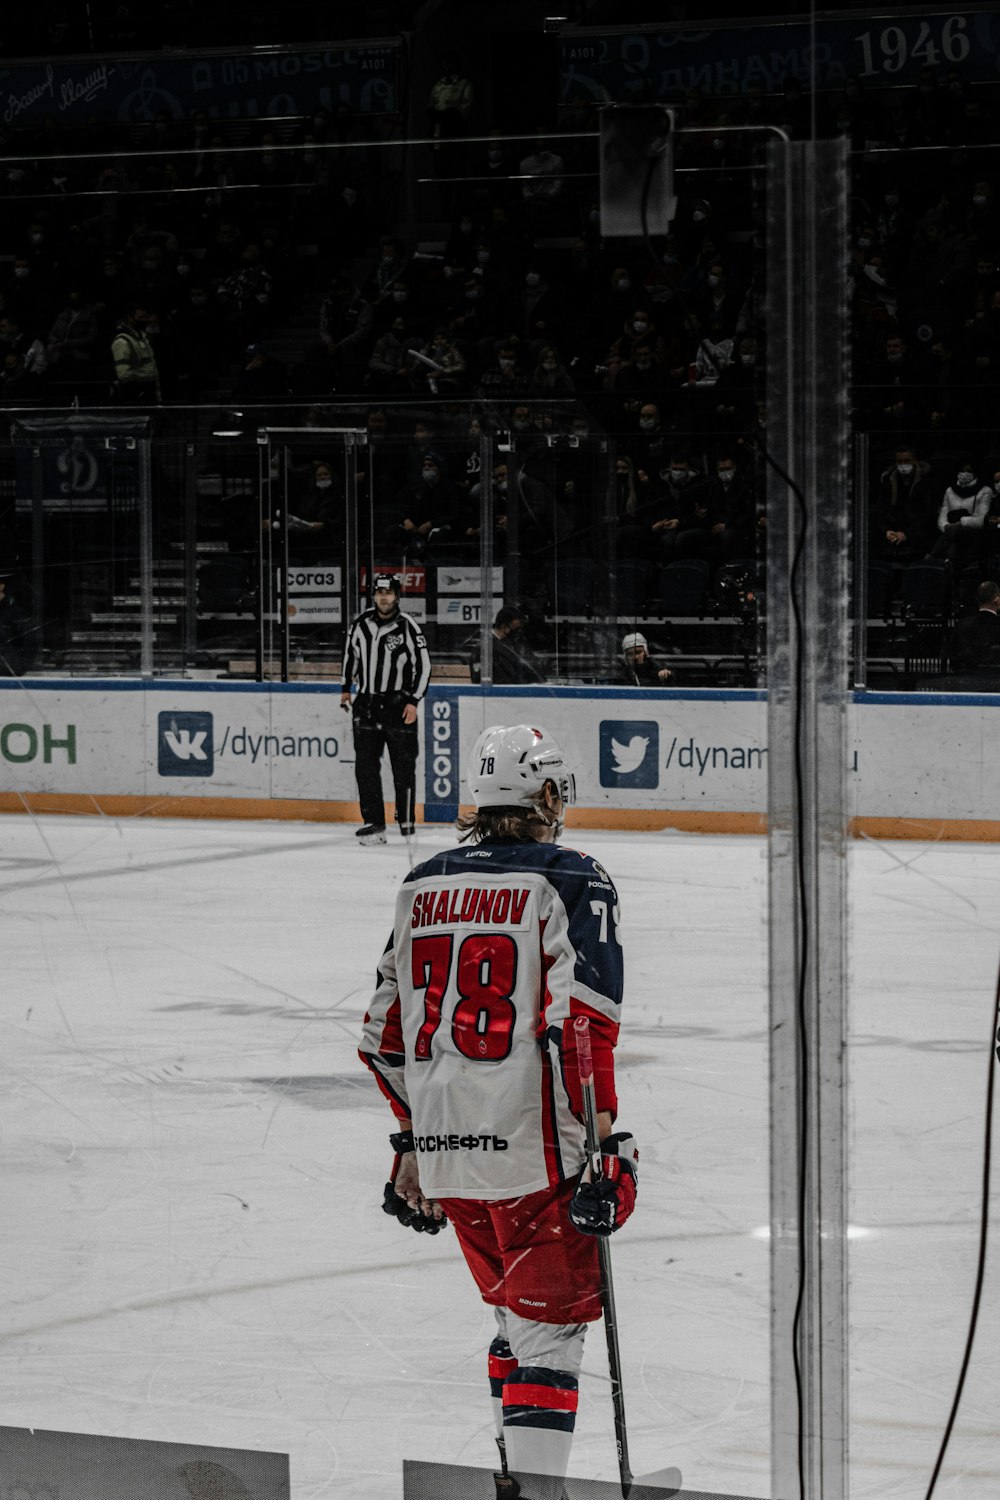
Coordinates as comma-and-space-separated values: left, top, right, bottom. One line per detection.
340, 573, 430, 845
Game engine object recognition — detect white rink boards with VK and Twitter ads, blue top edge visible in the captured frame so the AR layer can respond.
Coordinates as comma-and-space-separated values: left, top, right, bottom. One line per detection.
0, 678, 1000, 840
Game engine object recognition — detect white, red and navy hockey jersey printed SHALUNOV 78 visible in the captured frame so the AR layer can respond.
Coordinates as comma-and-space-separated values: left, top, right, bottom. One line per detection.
360, 840, 622, 1199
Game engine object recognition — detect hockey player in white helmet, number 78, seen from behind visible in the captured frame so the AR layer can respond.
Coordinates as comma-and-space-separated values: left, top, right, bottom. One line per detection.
360, 725, 637, 1500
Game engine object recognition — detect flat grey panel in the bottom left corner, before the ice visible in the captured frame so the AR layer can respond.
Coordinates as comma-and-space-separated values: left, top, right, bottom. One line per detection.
0, 1427, 291, 1500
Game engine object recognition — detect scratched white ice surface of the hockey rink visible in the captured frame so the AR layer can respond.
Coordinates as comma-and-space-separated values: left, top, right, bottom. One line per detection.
0, 818, 1000, 1500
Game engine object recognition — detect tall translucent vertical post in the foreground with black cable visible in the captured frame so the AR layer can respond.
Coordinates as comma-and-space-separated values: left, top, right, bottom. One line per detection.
768, 141, 850, 1500
